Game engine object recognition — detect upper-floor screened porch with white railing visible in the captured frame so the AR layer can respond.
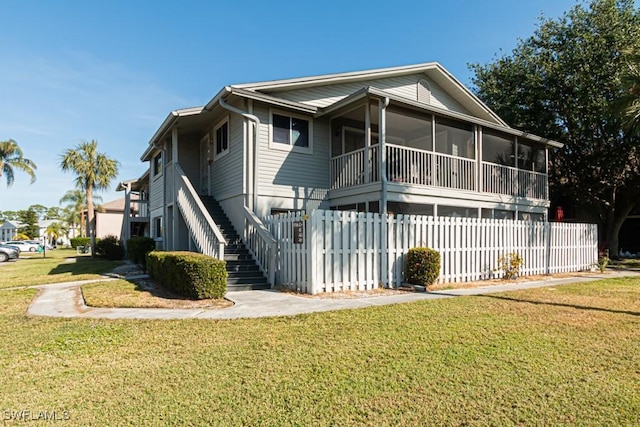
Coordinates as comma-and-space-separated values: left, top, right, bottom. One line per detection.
330, 101, 548, 200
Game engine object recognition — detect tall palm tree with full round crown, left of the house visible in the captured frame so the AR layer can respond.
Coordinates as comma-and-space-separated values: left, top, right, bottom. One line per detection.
60, 140, 119, 254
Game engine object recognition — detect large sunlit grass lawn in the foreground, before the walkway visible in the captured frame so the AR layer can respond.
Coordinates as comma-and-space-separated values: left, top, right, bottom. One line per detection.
0, 279, 640, 426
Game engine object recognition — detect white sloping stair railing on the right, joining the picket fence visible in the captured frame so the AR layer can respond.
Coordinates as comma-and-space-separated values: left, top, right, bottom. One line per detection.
244, 206, 278, 286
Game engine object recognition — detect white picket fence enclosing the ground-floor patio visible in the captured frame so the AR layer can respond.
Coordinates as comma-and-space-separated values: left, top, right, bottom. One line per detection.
263, 210, 598, 294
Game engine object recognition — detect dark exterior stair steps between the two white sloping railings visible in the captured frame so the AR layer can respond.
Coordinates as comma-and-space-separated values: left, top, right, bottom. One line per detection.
200, 196, 270, 291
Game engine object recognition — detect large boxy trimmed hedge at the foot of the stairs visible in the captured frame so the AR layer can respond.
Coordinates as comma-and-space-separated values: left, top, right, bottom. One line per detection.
147, 251, 227, 299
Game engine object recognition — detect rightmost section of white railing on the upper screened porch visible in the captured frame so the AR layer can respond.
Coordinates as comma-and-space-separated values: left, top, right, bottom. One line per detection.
482, 162, 549, 200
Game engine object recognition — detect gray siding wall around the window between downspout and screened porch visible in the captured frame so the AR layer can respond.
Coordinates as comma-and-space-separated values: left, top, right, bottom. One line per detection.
254, 105, 330, 210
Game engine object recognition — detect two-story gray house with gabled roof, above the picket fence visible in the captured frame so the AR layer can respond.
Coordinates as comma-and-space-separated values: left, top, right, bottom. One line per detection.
122, 63, 561, 290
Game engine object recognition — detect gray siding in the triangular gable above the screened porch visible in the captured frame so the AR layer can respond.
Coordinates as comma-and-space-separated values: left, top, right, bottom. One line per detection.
264, 74, 470, 114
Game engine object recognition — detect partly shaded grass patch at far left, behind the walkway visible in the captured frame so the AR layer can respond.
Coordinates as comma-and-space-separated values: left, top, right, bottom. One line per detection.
0, 249, 120, 289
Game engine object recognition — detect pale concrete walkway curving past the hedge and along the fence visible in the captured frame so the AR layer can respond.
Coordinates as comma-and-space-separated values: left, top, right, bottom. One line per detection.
21, 270, 640, 319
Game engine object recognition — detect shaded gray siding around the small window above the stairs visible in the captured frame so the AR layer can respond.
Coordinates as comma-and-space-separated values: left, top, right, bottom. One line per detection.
214, 112, 246, 200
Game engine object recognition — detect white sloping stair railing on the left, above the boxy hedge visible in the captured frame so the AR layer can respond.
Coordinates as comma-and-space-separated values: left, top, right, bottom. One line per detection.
173, 162, 227, 259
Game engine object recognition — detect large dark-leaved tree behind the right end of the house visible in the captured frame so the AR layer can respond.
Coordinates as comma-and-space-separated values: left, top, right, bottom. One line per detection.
471, 0, 640, 253
